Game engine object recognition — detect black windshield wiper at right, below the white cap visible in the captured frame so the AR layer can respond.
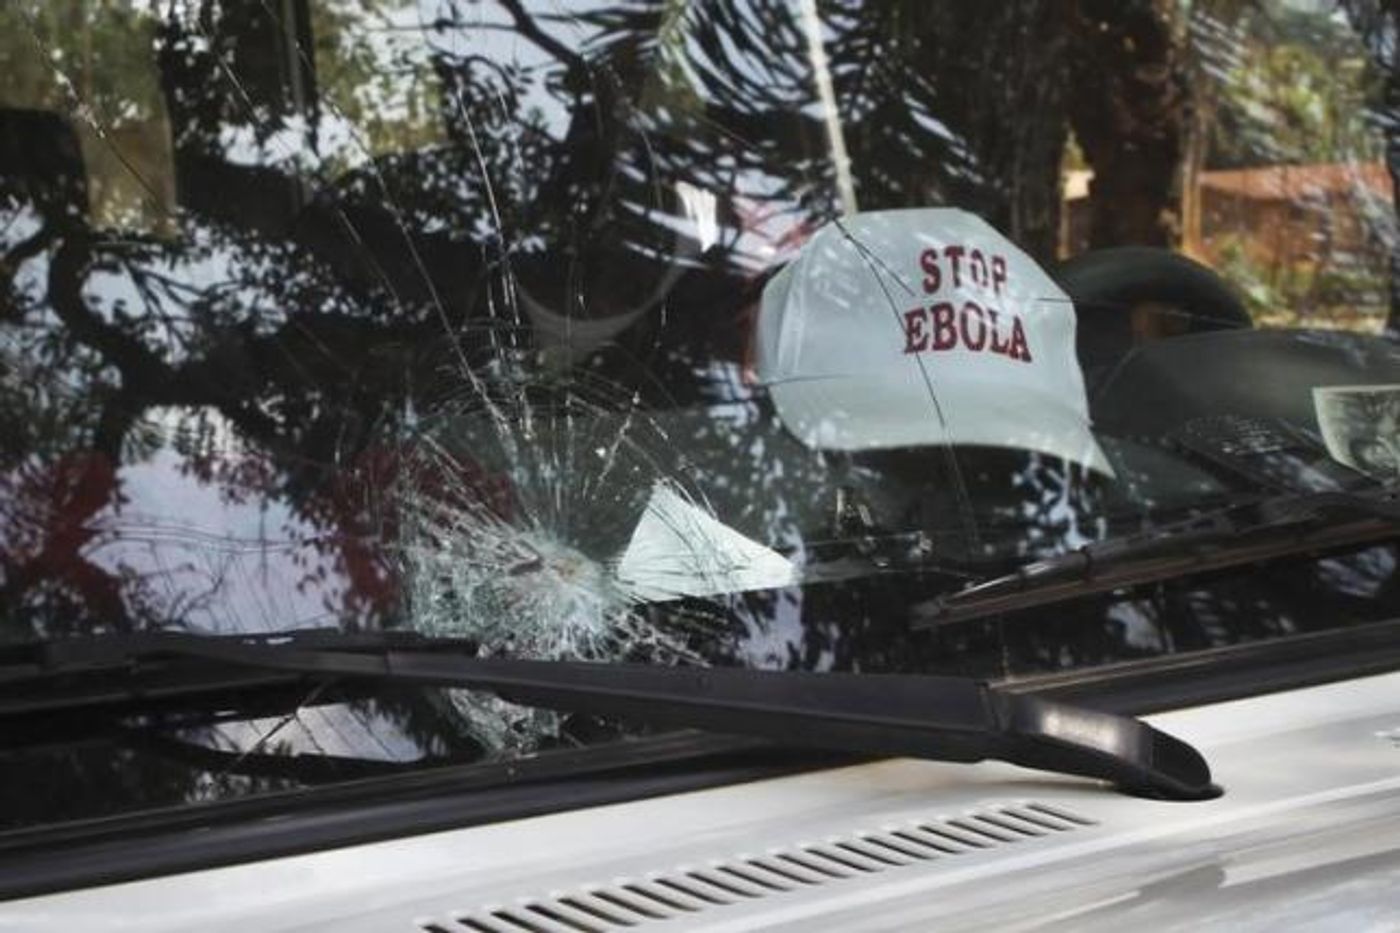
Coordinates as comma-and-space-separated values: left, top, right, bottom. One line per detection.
913, 489, 1400, 628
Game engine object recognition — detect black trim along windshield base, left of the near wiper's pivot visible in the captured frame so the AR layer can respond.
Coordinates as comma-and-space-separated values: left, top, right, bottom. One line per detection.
0, 734, 860, 901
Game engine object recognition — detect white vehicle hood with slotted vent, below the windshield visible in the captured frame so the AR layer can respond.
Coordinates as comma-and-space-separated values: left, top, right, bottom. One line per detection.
0, 674, 1400, 933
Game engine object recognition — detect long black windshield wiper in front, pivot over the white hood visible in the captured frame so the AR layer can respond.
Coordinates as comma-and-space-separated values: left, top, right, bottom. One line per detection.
0, 633, 1219, 800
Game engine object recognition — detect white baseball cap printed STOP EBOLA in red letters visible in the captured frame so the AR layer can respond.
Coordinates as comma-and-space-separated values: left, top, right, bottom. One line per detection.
755, 207, 1113, 475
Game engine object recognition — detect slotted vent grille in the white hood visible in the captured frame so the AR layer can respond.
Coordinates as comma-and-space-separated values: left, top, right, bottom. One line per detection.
417, 803, 1093, 933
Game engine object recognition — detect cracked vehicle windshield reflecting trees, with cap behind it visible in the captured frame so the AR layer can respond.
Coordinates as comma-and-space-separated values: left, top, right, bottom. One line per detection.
0, 0, 1400, 808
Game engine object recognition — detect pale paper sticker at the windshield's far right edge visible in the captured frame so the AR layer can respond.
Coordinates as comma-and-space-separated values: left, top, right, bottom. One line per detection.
1313, 385, 1400, 482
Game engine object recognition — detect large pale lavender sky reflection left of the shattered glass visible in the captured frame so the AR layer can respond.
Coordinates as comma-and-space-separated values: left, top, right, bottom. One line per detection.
91, 437, 347, 632
